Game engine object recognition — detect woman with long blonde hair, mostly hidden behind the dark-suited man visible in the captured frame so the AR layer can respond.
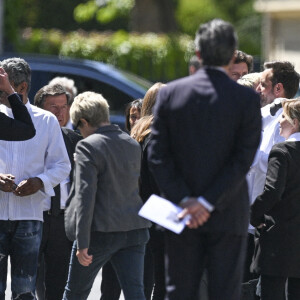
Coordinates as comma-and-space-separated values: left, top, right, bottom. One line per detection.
131, 82, 165, 300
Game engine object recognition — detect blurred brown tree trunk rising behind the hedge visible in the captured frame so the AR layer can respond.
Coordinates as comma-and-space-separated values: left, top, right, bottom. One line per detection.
131, 0, 177, 33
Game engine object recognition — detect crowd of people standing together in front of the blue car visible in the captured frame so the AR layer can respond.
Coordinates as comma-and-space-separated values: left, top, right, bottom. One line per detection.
0, 15, 300, 300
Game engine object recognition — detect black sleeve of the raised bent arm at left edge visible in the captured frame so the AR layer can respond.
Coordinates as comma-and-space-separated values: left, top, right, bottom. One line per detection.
0, 94, 35, 141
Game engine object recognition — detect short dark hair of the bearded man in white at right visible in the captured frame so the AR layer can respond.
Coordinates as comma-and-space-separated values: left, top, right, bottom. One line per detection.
264, 61, 300, 99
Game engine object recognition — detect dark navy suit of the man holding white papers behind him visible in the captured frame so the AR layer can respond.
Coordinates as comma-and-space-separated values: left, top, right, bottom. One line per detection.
149, 68, 261, 300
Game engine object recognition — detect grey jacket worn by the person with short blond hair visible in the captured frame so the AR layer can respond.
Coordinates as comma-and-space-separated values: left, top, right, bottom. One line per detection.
71, 125, 150, 249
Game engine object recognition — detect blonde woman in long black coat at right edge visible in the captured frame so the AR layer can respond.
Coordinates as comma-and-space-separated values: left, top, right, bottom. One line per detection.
251, 99, 300, 300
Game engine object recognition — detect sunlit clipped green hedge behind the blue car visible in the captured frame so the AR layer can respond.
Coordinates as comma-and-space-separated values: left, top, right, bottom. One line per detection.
18, 29, 194, 82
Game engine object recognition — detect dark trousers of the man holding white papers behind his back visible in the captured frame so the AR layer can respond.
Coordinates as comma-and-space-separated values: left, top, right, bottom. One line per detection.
166, 229, 247, 300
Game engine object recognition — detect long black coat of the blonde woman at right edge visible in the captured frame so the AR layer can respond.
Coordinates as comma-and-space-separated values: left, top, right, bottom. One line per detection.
251, 141, 300, 278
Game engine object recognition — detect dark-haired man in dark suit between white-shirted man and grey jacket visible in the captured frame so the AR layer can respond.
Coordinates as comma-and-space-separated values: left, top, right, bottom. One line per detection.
34, 84, 81, 300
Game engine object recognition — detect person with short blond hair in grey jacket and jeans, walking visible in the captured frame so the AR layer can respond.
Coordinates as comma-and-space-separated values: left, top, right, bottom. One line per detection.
63, 92, 150, 300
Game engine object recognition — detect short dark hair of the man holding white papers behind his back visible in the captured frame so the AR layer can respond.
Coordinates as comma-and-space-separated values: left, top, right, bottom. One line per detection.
195, 19, 237, 66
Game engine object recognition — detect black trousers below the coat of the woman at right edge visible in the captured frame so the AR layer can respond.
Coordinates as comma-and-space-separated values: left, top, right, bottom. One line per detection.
261, 275, 300, 300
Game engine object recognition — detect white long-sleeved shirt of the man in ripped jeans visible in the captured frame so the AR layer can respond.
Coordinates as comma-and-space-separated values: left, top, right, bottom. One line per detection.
0, 101, 71, 221
